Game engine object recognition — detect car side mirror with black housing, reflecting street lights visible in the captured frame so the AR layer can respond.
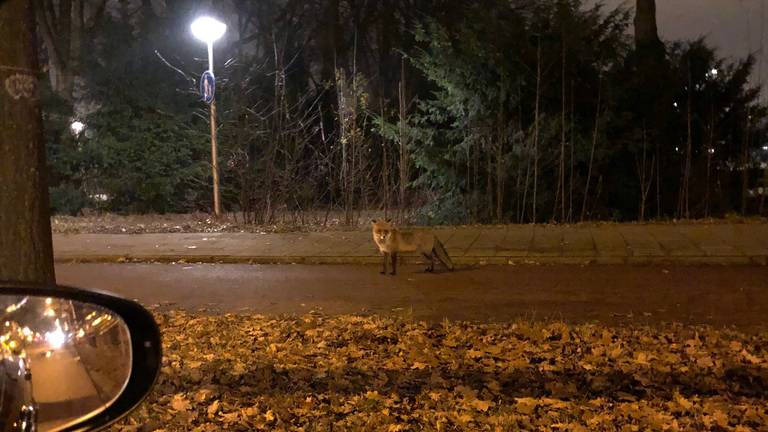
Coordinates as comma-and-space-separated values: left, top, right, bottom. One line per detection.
0, 283, 161, 432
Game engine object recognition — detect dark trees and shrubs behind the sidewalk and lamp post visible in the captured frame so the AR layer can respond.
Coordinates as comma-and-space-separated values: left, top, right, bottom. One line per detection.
43, 0, 768, 223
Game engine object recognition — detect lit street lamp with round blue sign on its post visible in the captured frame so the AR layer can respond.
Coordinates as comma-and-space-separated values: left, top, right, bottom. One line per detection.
190, 16, 227, 218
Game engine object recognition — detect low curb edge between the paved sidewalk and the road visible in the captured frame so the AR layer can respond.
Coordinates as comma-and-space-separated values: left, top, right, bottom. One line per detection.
54, 255, 768, 266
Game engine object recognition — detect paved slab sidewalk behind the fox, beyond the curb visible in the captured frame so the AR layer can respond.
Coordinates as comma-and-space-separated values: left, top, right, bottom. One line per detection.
53, 224, 768, 265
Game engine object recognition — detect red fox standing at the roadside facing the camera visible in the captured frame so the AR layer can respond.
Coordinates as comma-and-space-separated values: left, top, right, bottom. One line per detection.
371, 219, 453, 275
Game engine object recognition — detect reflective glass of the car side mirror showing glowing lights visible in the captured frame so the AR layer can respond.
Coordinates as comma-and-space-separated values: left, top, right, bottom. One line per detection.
0, 295, 131, 431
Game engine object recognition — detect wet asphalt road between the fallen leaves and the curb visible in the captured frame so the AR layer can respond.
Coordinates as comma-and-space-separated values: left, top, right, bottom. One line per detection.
56, 264, 768, 328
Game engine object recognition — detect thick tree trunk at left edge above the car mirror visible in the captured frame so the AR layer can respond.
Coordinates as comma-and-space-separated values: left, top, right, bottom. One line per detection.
0, 0, 56, 284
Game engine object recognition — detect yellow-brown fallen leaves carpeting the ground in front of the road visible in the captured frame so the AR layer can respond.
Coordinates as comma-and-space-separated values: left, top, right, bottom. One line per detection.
112, 310, 768, 432
